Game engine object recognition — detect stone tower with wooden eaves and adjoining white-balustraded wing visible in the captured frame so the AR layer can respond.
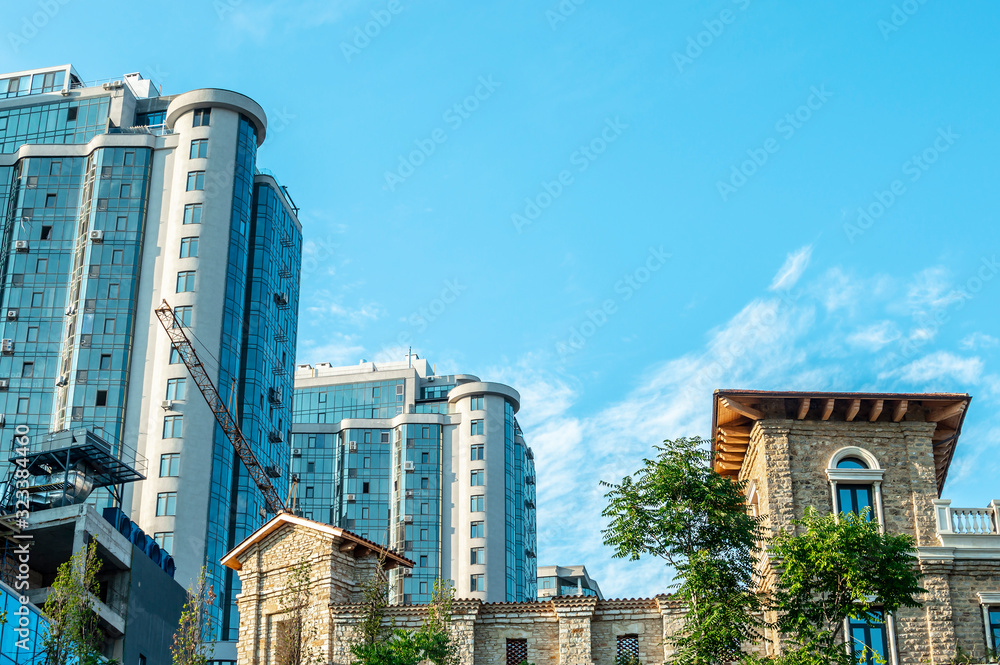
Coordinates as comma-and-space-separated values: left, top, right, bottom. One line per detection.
712, 390, 1000, 665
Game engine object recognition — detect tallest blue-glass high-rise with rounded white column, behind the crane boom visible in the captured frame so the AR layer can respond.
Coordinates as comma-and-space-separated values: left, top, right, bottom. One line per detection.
0, 65, 302, 660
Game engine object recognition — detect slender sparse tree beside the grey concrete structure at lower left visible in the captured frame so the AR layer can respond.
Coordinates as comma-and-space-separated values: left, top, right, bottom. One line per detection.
42, 538, 105, 665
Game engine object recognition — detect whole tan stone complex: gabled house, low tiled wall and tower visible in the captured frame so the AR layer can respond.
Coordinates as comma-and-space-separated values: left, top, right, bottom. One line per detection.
223, 390, 1000, 665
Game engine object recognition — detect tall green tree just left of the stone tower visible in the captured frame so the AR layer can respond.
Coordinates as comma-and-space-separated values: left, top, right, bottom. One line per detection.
602, 437, 763, 665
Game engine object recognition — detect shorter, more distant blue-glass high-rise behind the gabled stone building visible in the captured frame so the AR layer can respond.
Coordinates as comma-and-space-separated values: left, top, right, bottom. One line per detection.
292, 356, 537, 604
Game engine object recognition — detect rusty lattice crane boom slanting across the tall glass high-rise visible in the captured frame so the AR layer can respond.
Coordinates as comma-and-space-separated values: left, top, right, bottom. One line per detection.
153, 300, 285, 513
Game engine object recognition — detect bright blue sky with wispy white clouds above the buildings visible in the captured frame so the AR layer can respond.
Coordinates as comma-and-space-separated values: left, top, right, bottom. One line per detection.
0, 0, 1000, 596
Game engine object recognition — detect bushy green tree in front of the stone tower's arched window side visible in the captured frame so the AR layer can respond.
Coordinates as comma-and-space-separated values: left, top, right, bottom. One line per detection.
771, 508, 925, 665
